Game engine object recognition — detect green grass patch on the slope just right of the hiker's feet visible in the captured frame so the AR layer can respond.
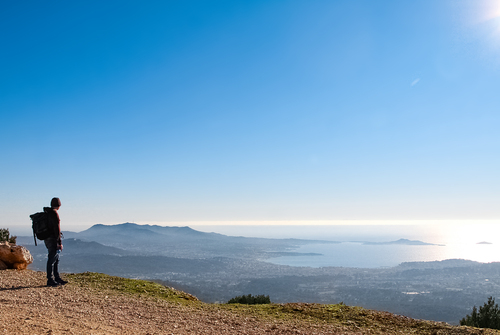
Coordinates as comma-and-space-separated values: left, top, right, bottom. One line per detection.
68, 272, 199, 303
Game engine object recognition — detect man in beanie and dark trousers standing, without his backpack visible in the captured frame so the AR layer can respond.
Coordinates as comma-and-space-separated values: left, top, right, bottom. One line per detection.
43, 198, 68, 287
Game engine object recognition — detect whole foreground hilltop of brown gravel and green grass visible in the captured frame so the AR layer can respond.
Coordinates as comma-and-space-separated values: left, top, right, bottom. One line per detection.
0, 270, 500, 335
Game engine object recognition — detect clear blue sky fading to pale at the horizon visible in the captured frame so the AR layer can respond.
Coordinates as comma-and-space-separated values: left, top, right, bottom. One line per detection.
0, 0, 500, 234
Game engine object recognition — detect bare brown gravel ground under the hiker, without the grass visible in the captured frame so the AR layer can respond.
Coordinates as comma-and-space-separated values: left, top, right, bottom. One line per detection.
0, 270, 361, 335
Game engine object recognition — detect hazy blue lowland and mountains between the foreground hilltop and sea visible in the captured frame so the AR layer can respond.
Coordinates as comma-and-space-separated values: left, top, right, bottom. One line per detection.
18, 223, 500, 324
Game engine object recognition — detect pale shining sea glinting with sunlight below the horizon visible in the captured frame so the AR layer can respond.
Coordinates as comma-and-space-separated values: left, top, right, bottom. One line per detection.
191, 223, 500, 268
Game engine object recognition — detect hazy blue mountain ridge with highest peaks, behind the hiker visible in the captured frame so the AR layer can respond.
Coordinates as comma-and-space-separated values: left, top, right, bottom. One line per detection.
64, 223, 335, 259
